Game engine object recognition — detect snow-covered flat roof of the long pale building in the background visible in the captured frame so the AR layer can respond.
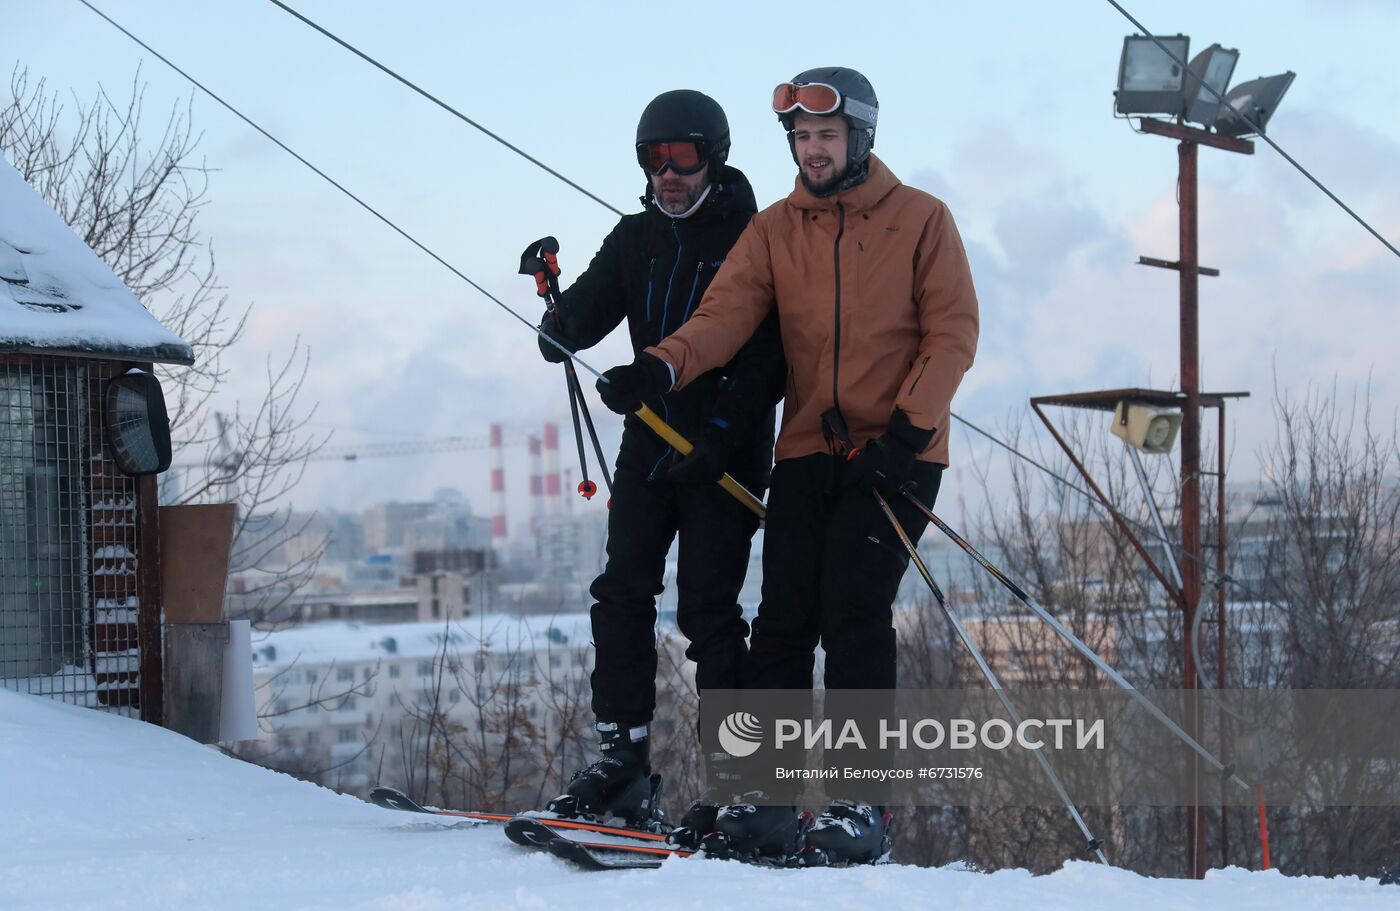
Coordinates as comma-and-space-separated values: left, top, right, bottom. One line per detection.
253, 613, 592, 670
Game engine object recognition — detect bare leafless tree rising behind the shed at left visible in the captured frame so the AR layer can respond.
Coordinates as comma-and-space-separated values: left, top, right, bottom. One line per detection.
0, 66, 323, 635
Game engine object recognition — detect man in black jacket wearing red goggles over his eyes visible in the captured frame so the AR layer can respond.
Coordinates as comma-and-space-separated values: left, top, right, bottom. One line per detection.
540, 90, 787, 824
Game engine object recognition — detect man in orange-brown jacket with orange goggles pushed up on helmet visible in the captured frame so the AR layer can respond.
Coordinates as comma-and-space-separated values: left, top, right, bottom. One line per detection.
598, 67, 977, 862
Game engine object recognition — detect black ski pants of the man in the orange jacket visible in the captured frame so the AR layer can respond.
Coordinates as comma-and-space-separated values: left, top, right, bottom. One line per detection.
745, 453, 942, 690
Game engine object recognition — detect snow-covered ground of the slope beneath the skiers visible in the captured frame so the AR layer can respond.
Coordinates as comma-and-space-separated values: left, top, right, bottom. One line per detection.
0, 690, 1400, 911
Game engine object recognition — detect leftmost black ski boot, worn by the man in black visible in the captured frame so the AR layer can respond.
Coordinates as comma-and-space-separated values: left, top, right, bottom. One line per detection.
546, 722, 661, 828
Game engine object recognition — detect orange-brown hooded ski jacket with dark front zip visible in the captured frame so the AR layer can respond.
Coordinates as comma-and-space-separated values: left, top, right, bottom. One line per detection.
647, 155, 977, 465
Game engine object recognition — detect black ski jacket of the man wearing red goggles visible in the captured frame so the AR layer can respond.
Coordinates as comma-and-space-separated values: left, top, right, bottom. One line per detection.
548, 165, 787, 488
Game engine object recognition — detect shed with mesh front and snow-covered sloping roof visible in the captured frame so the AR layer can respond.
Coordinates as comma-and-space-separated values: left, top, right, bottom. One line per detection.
0, 158, 193, 723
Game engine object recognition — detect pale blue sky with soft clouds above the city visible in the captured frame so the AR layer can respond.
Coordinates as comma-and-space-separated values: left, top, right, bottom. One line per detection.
0, 0, 1400, 526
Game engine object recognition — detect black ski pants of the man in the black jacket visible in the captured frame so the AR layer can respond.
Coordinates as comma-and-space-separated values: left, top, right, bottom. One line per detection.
589, 465, 763, 726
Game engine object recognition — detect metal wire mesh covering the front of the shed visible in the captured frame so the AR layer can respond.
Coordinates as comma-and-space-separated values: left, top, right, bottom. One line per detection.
0, 358, 140, 714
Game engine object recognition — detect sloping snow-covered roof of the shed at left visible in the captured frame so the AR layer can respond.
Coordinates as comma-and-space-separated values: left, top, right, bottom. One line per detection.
0, 155, 195, 364
